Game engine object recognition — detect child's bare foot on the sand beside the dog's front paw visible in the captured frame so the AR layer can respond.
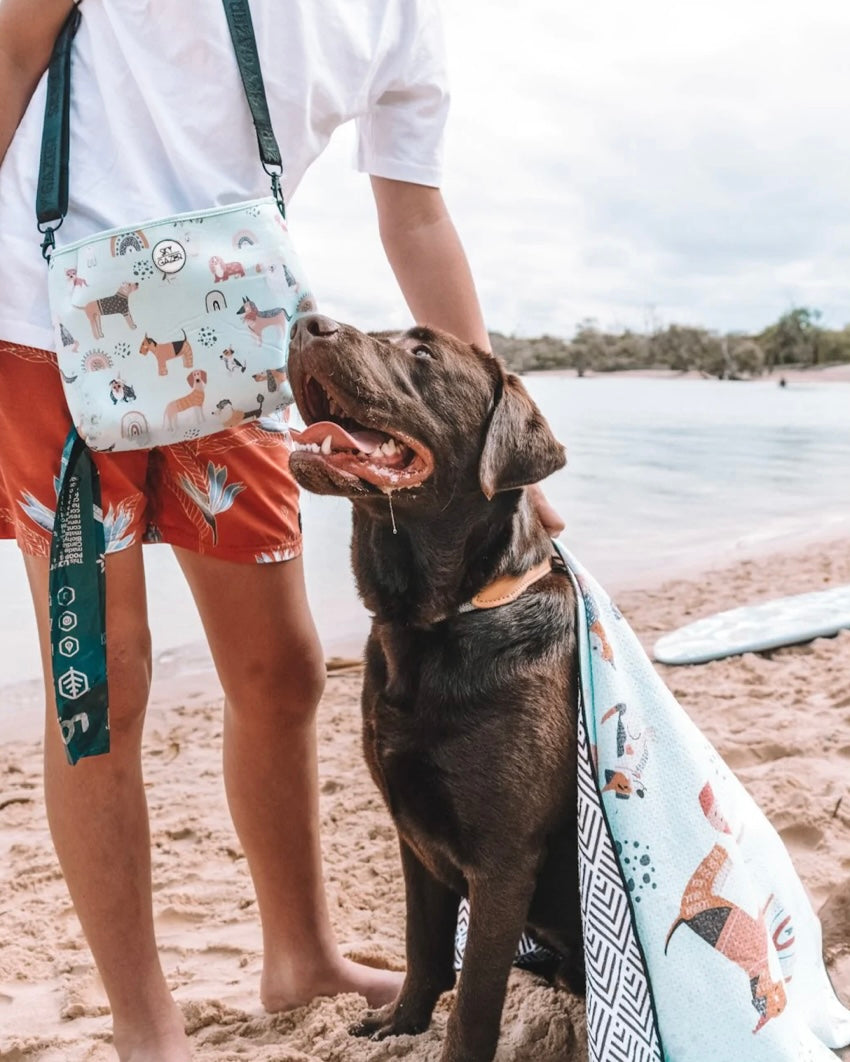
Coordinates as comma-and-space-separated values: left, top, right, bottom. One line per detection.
260, 956, 404, 1012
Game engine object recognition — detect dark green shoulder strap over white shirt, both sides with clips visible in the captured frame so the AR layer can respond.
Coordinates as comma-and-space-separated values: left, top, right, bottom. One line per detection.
35, 0, 286, 258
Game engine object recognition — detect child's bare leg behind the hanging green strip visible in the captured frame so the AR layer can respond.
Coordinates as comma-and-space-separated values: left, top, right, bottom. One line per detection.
24, 546, 190, 1062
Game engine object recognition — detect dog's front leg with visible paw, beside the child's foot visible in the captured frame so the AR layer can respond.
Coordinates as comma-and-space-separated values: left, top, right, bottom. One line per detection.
351, 841, 460, 1040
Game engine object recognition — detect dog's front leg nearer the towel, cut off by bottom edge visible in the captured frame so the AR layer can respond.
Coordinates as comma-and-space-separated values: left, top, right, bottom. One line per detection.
441, 866, 534, 1062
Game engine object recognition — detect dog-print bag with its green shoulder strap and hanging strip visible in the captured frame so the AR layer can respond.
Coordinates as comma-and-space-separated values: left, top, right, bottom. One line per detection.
36, 0, 313, 764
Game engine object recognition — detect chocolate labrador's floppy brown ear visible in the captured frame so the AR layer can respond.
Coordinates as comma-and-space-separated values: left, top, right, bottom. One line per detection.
478, 363, 566, 498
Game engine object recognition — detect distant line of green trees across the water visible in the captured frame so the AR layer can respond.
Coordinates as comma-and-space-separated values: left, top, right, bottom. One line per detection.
490, 307, 850, 379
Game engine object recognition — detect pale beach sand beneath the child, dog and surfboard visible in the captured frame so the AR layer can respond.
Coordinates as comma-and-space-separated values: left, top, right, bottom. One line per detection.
0, 543, 850, 1062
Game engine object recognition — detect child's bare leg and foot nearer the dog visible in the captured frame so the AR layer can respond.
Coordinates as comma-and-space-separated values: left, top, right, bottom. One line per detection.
175, 549, 402, 1010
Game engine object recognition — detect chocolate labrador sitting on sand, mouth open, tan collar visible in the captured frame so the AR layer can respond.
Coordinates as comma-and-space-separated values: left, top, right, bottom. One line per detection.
289, 315, 583, 1062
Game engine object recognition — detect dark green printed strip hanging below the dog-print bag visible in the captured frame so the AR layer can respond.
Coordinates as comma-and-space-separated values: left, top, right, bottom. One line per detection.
49, 428, 109, 764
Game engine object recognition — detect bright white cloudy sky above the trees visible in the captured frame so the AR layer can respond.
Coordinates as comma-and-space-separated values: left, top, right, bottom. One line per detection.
289, 0, 850, 337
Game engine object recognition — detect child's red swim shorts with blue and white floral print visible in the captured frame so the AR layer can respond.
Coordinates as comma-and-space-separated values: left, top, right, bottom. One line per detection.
0, 341, 301, 563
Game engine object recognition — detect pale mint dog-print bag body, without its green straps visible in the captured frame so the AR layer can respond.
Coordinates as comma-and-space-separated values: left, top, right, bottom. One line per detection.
49, 198, 313, 450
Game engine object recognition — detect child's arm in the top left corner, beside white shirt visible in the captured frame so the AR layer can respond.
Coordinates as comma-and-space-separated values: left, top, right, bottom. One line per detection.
0, 0, 73, 162
